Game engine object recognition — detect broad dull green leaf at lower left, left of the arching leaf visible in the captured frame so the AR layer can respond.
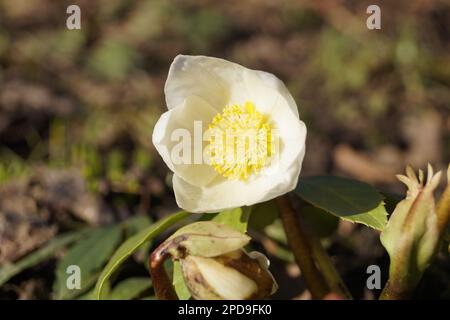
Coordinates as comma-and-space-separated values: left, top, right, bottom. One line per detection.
53, 226, 121, 300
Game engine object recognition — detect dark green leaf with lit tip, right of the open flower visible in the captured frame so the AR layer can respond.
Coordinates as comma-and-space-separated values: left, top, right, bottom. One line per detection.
295, 176, 387, 230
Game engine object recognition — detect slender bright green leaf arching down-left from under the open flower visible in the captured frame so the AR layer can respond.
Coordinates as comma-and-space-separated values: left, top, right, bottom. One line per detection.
95, 211, 190, 299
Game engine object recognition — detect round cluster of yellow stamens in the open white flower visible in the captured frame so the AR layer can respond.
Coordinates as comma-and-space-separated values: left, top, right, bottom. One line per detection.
208, 102, 274, 180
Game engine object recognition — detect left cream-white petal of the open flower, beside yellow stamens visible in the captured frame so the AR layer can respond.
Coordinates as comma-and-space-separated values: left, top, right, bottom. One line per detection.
152, 96, 217, 186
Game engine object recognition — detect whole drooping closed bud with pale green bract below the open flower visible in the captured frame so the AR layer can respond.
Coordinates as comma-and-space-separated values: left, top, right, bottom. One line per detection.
157, 221, 277, 300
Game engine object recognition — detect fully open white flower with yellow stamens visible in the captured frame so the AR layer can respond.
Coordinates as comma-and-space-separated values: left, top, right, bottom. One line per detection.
153, 55, 306, 212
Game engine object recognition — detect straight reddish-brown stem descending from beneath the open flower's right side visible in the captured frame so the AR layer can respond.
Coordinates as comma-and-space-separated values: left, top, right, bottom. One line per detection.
275, 195, 329, 299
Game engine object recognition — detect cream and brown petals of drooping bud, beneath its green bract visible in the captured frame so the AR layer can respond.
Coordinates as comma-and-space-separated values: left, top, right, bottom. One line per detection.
180, 250, 277, 300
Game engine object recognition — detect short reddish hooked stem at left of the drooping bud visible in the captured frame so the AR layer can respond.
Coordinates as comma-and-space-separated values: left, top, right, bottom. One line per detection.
149, 243, 178, 300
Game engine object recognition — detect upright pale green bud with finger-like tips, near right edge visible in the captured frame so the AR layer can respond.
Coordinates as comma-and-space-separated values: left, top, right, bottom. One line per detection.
381, 165, 441, 298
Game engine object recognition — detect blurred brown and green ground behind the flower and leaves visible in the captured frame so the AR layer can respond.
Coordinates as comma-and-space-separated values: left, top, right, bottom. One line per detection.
0, 0, 450, 299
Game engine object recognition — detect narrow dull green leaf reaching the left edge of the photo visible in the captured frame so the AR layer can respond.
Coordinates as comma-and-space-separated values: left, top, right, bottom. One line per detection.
0, 230, 87, 286
